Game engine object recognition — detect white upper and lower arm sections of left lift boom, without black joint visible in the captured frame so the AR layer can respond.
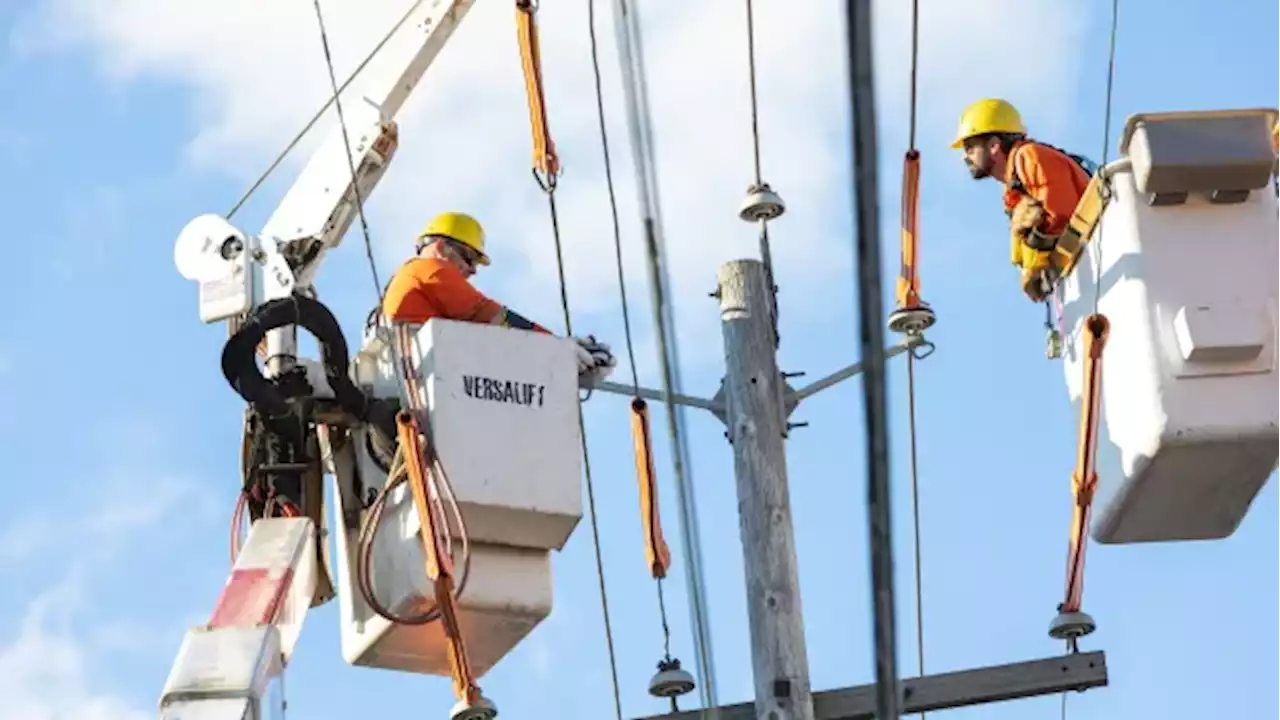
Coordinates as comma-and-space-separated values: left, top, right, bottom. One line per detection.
160, 0, 475, 720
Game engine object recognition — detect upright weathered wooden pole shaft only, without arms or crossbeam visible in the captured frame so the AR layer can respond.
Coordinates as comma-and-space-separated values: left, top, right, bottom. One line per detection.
717, 260, 814, 720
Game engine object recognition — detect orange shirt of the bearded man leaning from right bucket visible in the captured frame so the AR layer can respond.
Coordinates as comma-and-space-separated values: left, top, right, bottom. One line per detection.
1005, 140, 1089, 236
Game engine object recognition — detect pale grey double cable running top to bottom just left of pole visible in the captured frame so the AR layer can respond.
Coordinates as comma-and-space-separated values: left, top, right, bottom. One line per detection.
614, 0, 717, 707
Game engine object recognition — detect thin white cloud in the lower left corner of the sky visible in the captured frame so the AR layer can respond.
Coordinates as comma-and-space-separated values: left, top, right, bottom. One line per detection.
0, 445, 206, 720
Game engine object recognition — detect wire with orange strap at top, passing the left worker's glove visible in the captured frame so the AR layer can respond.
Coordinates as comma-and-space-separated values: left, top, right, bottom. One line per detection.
516, 0, 622, 720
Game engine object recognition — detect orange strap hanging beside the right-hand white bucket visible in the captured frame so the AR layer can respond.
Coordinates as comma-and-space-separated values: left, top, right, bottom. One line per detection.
1061, 314, 1111, 612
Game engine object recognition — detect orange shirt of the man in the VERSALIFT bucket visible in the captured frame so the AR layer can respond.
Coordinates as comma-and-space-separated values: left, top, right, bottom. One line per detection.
383, 258, 503, 323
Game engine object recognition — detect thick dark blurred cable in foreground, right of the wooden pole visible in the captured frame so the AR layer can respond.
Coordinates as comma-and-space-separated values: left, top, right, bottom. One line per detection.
845, 0, 901, 717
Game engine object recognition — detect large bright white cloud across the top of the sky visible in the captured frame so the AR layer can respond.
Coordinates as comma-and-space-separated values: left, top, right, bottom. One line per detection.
15, 0, 1088, 368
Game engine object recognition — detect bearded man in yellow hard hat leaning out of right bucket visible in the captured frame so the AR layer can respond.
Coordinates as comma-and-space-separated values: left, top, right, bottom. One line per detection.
951, 99, 1092, 302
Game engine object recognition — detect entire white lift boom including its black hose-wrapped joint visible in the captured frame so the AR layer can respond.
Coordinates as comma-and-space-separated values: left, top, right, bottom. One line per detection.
160, 0, 475, 720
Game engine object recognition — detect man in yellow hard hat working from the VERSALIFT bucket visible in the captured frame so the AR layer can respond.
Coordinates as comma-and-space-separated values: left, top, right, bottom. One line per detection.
381, 213, 617, 379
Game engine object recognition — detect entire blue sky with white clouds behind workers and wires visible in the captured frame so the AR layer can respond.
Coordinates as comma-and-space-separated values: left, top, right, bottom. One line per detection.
0, 0, 1280, 720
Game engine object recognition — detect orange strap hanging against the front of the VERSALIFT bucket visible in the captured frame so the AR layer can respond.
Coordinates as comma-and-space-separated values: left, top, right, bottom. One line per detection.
396, 411, 480, 702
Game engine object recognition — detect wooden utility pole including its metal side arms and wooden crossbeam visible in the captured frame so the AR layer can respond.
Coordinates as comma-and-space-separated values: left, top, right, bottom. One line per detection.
595, 266, 1107, 720
